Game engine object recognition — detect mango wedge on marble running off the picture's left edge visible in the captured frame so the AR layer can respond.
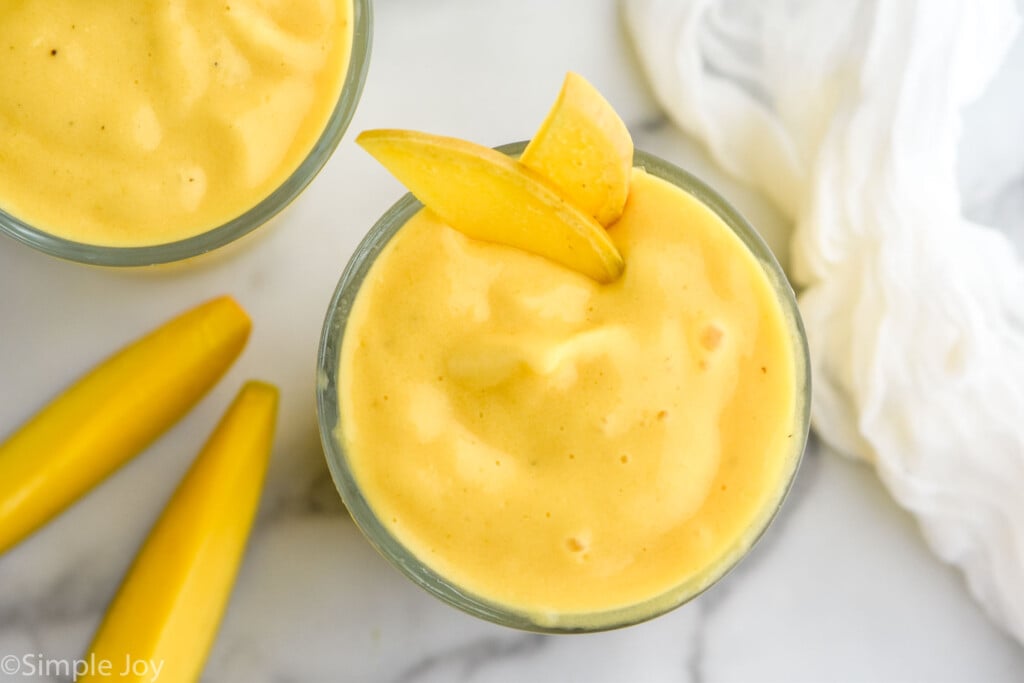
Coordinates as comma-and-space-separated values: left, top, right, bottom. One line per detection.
0, 297, 251, 553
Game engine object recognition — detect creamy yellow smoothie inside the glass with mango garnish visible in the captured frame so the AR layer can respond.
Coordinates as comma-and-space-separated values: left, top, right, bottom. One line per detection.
338, 169, 804, 625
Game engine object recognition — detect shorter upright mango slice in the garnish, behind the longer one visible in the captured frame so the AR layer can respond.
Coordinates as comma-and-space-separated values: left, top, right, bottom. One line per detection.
520, 72, 633, 226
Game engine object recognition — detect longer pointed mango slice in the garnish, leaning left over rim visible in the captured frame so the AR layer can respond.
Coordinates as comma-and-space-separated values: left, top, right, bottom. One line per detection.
355, 130, 623, 283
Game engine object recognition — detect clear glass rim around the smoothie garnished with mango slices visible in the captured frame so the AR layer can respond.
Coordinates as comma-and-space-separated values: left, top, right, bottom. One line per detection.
316, 141, 811, 634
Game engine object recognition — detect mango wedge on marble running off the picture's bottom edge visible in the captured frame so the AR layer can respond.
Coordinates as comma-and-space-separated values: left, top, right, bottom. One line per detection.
78, 382, 278, 682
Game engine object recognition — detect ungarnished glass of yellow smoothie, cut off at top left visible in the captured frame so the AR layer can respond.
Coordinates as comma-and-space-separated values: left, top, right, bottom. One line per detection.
0, 0, 372, 266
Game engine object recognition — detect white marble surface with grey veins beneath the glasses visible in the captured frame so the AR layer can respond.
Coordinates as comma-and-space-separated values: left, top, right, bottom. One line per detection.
0, 0, 1024, 683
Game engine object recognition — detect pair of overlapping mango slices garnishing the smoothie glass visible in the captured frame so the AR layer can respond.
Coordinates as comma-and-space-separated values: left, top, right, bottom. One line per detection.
356, 73, 633, 283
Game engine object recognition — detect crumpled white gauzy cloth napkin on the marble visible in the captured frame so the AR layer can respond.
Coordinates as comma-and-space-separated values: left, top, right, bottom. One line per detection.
623, 0, 1024, 641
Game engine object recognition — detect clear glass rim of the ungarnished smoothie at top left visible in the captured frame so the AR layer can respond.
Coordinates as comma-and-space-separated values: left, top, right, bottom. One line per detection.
0, 0, 373, 267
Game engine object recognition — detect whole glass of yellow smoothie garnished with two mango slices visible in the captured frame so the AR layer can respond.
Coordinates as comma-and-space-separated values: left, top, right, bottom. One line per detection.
317, 75, 810, 633
